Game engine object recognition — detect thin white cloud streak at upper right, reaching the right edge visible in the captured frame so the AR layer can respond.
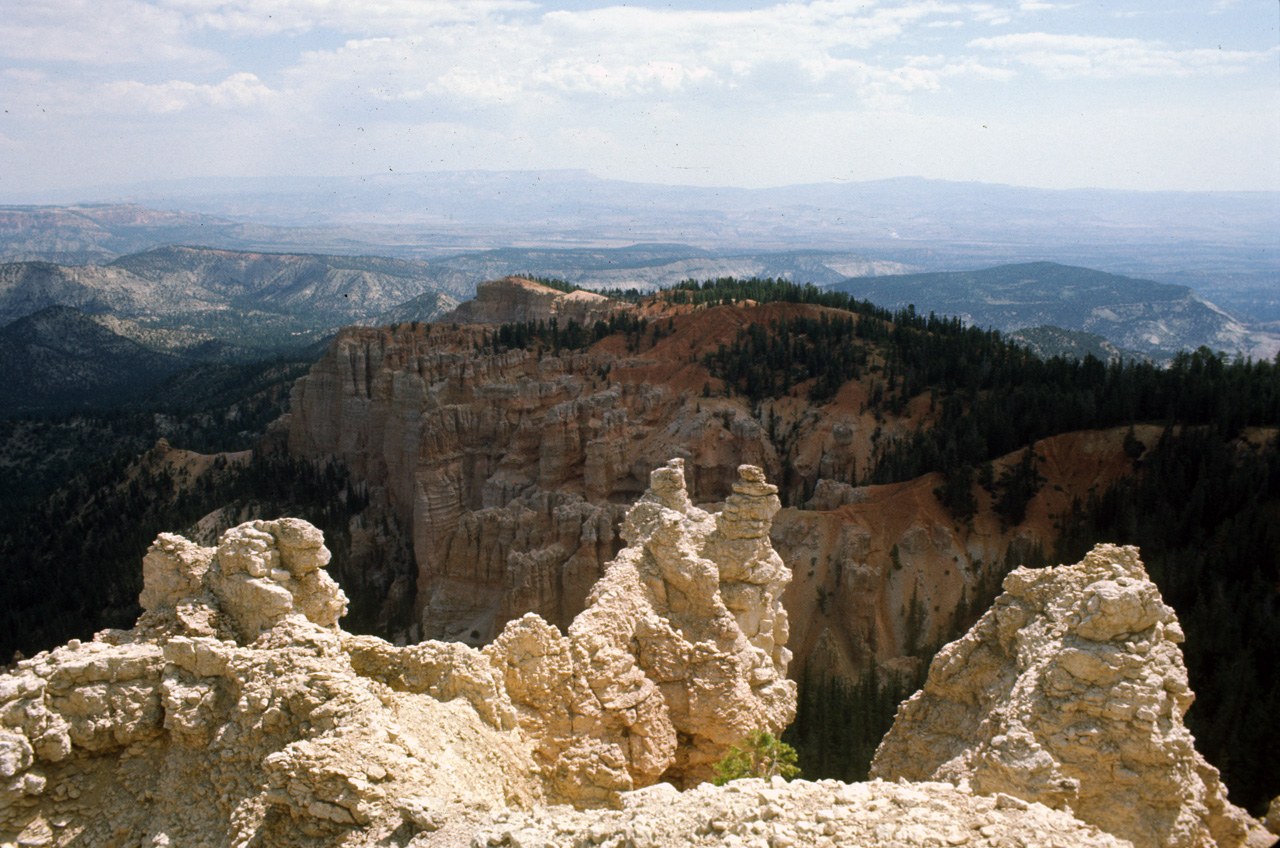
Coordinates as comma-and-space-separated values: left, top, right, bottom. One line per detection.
969, 32, 1277, 79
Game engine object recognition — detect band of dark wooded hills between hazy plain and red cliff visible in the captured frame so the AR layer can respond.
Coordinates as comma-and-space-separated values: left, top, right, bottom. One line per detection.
0, 245, 1280, 415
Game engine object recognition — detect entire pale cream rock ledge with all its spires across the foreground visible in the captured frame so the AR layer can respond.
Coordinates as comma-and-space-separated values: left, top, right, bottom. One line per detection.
0, 460, 1275, 848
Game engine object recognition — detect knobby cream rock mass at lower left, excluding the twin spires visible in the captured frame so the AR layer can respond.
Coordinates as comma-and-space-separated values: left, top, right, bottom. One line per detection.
0, 519, 541, 848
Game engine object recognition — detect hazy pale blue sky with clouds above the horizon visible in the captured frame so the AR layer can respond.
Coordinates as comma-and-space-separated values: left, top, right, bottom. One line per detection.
0, 0, 1280, 202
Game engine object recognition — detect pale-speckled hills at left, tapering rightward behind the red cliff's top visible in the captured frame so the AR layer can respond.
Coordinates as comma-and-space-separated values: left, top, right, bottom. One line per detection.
0, 245, 909, 350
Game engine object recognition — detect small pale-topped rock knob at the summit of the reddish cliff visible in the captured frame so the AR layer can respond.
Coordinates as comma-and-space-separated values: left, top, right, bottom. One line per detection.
438, 277, 617, 324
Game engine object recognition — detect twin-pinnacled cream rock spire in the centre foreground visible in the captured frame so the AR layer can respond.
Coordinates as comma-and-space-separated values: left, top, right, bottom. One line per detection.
485, 459, 796, 806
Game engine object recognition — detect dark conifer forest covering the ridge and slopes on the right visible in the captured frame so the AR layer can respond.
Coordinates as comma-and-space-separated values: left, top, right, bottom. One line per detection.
667, 281, 1280, 812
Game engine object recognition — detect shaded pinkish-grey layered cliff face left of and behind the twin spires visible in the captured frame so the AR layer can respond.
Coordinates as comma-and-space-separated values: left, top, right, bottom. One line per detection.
289, 315, 793, 643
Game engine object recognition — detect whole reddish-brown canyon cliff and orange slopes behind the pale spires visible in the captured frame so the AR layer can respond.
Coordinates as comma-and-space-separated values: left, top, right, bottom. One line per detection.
290, 279, 1158, 676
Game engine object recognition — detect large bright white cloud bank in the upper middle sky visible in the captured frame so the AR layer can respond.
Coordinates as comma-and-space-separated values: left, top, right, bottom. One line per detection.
277, 0, 977, 116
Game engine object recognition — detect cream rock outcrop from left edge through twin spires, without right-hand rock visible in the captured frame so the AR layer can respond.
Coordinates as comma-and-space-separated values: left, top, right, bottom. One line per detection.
0, 468, 795, 847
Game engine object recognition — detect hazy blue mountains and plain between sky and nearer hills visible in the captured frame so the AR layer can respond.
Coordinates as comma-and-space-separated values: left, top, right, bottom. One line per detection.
0, 170, 1280, 323
